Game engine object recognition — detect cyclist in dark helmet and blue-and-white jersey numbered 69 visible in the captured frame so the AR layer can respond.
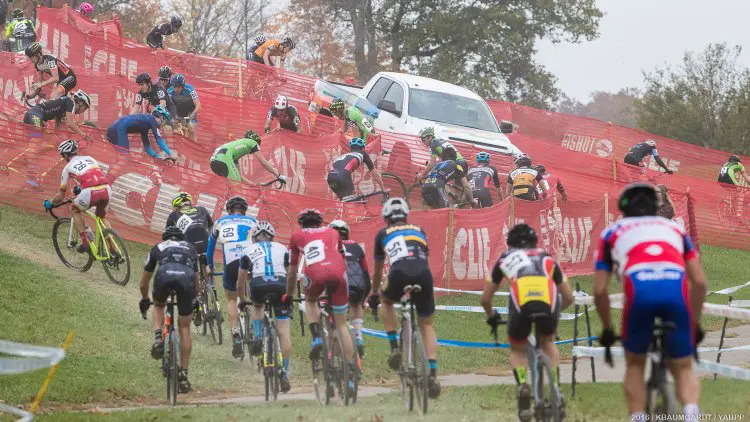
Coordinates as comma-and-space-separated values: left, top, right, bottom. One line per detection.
206, 196, 256, 358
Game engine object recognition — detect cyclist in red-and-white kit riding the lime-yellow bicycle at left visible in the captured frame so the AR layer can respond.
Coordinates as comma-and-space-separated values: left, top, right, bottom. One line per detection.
44, 139, 112, 253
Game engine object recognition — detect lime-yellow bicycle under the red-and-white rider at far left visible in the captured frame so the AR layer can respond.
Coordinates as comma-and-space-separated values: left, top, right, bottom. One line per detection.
47, 198, 130, 286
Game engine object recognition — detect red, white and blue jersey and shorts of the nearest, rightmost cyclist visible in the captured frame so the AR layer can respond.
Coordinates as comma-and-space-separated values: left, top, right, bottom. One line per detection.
596, 217, 698, 358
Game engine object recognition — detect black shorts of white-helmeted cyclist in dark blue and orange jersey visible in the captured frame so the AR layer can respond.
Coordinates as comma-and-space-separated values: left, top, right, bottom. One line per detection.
383, 261, 435, 317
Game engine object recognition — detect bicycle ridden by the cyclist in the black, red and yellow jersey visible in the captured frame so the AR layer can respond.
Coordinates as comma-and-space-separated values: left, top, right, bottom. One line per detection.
492, 312, 565, 422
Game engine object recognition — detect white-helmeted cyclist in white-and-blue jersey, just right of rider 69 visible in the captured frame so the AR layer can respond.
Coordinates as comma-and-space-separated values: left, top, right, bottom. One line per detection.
237, 221, 292, 393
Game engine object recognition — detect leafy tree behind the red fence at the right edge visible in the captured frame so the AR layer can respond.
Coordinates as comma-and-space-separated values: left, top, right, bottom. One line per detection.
636, 44, 750, 154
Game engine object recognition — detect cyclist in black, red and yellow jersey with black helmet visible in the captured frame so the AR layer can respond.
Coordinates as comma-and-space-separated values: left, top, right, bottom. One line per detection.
481, 223, 573, 421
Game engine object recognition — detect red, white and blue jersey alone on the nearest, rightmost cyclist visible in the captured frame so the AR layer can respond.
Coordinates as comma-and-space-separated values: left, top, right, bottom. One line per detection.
596, 217, 698, 281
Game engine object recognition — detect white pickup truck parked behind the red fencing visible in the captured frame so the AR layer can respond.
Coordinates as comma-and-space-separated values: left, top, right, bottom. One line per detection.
311, 72, 520, 155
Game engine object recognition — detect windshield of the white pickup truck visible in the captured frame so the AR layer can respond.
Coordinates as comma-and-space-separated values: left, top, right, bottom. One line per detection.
409, 88, 500, 133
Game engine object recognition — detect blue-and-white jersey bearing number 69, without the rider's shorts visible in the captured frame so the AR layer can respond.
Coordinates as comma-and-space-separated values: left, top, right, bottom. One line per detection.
206, 214, 256, 266
